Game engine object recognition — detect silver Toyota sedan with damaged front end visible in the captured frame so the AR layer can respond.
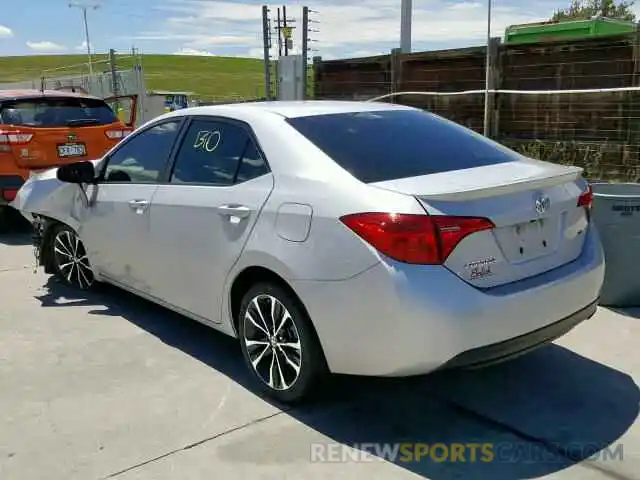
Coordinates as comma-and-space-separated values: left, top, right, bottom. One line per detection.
13, 101, 604, 402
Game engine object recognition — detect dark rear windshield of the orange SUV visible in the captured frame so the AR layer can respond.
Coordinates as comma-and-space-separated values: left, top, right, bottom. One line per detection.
0, 97, 118, 127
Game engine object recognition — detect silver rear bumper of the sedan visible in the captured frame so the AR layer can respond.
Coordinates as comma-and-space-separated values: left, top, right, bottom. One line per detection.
291, 226, 604, 376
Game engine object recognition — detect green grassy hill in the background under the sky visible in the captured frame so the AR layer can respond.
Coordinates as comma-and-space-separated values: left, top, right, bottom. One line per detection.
0, 55, 264, 100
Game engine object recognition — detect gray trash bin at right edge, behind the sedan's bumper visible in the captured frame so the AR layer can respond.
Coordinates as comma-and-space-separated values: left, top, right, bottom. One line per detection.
592, 183, 640, 307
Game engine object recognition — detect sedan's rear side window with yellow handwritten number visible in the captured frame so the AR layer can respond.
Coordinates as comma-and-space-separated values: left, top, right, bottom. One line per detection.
171, 119, 267, 185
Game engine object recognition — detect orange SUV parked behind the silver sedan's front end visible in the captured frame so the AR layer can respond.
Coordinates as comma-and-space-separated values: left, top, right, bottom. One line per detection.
0, 90, 136, 227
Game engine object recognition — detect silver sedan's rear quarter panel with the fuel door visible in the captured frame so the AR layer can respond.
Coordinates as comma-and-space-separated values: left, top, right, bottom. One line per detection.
234, 115, 424, 281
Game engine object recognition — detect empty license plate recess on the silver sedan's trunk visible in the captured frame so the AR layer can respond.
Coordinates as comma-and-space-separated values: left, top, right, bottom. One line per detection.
495, 217, 560, 263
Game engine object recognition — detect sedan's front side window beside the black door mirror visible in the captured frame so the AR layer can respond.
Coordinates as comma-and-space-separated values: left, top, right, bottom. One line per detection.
103, 120, 180, 183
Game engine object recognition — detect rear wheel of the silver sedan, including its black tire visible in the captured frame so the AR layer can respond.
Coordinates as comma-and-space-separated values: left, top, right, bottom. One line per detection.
238, 283, 327, 403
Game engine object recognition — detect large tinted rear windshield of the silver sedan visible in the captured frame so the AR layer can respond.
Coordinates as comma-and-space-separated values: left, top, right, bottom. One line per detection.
287, 110, 522, 183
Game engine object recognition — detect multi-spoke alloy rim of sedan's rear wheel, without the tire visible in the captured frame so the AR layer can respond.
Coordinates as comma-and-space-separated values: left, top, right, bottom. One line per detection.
243, 295, 302, 391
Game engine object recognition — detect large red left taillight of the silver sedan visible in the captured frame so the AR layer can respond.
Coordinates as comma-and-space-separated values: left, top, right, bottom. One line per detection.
340, 213, 494, 265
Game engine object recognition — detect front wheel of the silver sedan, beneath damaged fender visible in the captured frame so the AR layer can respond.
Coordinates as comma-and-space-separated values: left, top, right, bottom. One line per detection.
49, 224, 95, 290
